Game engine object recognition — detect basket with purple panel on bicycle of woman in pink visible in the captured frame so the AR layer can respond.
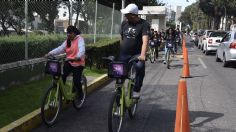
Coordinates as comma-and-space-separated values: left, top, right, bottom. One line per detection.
45, 61, 61, 76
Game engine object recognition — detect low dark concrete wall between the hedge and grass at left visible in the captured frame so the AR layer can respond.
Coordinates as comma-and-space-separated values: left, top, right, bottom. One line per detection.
0, 59, 45, 92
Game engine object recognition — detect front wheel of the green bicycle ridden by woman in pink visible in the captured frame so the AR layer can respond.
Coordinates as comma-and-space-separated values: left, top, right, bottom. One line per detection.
41, 85, 62, 126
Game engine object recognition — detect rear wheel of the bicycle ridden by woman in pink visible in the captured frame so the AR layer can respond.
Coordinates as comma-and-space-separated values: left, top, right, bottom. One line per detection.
73, 75, 87, 110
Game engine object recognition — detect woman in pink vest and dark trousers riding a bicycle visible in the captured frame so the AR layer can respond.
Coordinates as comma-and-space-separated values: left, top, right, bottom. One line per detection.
45, 26, 85, 99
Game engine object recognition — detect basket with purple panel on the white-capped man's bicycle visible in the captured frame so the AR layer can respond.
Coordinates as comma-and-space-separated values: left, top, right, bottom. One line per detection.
108, 62, 128, 78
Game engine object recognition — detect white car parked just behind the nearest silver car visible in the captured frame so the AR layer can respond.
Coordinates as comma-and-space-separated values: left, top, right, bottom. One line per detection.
203, 31, 227, 55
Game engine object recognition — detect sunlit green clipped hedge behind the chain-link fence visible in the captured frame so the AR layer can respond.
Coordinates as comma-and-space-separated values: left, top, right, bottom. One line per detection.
0, 34, 117, 64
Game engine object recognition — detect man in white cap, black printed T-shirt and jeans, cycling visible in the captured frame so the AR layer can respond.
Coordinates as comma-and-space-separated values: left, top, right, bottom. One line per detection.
120, 4, 150, 98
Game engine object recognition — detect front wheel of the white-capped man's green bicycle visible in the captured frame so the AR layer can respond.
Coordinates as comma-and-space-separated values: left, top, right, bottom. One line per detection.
108, 92, 123, 132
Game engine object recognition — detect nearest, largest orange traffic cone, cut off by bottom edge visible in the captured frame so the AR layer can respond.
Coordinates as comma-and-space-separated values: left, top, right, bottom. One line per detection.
175, 79, 190, 132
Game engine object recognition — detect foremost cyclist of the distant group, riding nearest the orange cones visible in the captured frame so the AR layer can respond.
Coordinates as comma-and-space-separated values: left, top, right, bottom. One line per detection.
163, 28, 175, 64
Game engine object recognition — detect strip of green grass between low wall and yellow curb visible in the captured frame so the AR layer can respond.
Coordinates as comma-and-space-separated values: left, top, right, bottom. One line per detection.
0, 68, 106, 128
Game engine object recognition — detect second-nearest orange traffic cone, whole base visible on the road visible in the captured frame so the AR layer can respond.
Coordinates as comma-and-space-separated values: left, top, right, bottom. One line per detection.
181, 48, 191, 78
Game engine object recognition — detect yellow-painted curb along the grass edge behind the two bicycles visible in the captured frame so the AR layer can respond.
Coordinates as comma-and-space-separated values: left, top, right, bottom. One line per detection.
0, 74, 111, 132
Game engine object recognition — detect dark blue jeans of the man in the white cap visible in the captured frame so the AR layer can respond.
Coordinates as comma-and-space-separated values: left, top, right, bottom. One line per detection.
119, 54, 145, 92
